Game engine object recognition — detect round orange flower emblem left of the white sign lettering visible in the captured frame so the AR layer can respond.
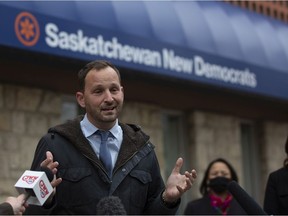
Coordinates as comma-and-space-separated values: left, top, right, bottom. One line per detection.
14, 12, 40, 46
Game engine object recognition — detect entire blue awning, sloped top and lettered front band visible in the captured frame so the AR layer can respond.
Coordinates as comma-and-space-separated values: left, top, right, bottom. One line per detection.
0, 1, 288, 100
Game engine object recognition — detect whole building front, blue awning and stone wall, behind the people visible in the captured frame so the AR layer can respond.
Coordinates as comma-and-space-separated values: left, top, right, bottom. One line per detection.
0, 2, 288, 213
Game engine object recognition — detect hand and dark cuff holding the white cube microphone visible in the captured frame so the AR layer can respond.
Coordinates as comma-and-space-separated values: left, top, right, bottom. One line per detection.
0, 194, 27, 215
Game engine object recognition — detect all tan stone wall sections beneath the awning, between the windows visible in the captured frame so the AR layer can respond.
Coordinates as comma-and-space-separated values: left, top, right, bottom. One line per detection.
0, 84, 288, 208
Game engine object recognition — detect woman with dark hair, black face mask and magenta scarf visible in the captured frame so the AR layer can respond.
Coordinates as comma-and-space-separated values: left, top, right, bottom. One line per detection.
184, 158, 246, 215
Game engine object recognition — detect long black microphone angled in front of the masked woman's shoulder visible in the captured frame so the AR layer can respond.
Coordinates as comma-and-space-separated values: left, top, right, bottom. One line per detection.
228, 181, 267, 215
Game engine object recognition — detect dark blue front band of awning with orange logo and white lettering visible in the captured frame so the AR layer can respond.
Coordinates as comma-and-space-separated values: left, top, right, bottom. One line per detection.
0, 3, 288, 100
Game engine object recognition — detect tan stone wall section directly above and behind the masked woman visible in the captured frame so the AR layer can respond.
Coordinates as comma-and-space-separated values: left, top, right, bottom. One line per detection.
189, 111, 242, 198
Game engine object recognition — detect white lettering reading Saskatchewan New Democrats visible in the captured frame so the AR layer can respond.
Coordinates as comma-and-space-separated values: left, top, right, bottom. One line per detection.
45, 23, 257, 88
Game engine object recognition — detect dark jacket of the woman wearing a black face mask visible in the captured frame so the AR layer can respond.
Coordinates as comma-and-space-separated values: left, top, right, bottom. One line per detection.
184, 195, 247, 215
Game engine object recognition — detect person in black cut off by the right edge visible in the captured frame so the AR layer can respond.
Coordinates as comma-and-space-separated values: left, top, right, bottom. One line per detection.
263, 136, 288, 215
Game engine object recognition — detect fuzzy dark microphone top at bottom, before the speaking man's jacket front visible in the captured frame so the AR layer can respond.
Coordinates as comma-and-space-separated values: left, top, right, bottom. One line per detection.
96, 196, 127, 215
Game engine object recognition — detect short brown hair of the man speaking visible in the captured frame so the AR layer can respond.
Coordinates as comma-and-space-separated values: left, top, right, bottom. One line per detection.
78, 60, 121, 91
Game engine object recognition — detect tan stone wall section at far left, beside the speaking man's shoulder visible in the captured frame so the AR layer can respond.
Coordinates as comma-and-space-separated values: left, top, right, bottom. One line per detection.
0, 85, 61, 201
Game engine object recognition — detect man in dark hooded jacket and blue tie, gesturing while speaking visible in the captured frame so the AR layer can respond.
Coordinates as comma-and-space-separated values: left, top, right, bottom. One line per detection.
25, 60, 197, 215
